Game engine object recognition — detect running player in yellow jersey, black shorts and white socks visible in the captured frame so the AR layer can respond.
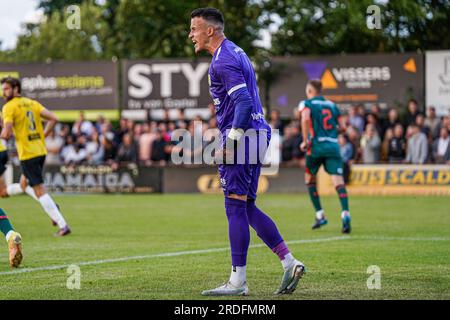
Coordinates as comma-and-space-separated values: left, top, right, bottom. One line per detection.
0, 77, 71, 236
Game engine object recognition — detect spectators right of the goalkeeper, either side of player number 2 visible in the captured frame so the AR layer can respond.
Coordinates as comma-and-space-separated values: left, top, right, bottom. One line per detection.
276, 99, 450, 164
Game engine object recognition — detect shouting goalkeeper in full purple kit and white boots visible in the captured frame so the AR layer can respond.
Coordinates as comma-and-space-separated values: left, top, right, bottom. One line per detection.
189, 8, 305, 296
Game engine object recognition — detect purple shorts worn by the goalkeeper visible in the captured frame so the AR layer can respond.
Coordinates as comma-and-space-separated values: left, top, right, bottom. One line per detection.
219, 164, 261, 199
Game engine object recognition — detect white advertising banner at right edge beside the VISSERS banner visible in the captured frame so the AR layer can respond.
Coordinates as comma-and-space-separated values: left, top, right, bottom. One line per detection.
425, 51, 450, 116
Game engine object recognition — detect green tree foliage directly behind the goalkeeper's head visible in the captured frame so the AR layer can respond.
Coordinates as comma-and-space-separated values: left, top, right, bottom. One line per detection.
110, 0, 263, 58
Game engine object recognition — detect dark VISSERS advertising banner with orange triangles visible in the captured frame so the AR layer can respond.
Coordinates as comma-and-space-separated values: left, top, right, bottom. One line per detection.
270, 53, 424, 117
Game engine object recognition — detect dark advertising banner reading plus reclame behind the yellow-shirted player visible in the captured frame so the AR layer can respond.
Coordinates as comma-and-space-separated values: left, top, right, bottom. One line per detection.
0, 61, 118, 111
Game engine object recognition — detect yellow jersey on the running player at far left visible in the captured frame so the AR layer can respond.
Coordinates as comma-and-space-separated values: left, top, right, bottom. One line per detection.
2, 97, 47, 160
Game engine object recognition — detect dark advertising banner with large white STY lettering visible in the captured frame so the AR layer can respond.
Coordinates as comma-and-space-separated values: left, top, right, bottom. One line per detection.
122, 59, 211, 110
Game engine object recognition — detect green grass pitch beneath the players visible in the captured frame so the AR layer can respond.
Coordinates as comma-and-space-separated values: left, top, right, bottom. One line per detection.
0, 194, 450, 300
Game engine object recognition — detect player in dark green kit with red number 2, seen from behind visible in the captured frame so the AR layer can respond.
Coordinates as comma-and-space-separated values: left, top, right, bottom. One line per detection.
299, 80, 351, 233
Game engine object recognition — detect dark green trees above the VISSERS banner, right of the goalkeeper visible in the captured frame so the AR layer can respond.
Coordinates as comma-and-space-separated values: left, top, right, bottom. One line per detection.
263, 0, 450, 55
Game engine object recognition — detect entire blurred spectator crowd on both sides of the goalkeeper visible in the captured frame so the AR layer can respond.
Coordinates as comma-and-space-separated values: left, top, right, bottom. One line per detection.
4, 100, 450, 166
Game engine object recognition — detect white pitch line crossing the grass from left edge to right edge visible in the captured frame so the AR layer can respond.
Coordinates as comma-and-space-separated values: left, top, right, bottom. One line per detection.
0, 236, 450, 276
